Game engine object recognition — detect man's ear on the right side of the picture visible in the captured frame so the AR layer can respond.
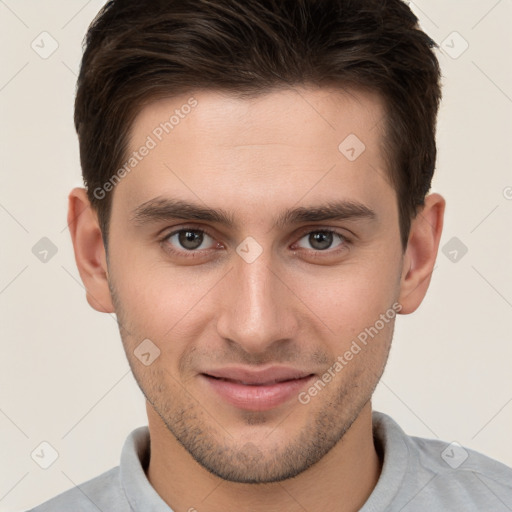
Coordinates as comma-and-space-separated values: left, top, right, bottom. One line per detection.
399, 194, 446, 315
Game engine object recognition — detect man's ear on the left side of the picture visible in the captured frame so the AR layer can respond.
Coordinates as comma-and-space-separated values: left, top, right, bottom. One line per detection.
68, 188, 114, 313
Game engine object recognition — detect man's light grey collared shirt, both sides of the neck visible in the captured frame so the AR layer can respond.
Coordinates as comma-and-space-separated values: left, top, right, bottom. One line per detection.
30, 411, 512, 512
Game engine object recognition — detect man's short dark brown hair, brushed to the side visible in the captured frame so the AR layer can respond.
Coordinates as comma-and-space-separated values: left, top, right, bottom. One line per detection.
75, 0, 441, 249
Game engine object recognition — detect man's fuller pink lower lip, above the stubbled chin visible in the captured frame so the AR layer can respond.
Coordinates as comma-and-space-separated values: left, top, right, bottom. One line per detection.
201, 374, 314, 411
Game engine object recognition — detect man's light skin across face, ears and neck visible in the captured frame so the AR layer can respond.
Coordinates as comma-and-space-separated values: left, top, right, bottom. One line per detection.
68, 88, 445, 512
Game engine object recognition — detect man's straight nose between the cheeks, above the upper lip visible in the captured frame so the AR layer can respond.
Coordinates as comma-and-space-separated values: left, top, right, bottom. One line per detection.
217, 250, 300, 355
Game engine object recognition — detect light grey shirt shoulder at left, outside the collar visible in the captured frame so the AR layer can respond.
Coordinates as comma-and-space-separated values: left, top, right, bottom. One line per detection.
28, 466, 131, 512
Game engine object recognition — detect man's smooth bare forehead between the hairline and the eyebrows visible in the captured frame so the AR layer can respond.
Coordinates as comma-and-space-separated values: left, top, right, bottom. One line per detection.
113, 88, 393, 224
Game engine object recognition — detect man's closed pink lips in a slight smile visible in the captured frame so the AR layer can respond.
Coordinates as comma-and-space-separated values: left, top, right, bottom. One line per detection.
200, 367, 315, 411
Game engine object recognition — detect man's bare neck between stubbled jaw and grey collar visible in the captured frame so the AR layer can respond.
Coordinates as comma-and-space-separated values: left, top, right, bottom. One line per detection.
147, 402, 382, 512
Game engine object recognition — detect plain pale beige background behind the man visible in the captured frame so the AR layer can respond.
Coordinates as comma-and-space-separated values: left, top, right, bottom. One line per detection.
0, 0, 512, 511
